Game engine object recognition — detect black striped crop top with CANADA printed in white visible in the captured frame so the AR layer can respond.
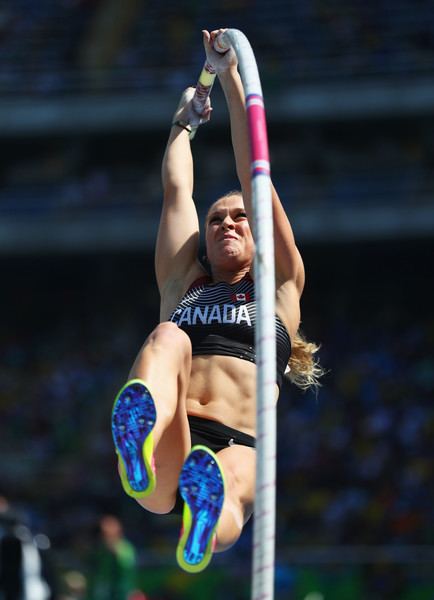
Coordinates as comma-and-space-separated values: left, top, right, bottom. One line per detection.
170, 274, 291, 387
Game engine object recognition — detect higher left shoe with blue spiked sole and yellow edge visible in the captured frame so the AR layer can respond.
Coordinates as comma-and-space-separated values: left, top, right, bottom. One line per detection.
112, 379, 157, 498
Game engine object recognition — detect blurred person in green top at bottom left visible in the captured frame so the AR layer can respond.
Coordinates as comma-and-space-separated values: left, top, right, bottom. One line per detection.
87, 515, 142, 600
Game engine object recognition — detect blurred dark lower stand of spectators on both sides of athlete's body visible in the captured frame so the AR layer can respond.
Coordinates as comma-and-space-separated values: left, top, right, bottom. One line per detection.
0, 239, 434, 596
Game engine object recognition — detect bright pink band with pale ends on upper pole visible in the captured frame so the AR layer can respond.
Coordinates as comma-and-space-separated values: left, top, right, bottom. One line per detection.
246, 94, 270, 177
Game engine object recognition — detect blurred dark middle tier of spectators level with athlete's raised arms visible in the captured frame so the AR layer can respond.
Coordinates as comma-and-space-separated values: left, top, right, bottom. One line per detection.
0, 115, 434, 219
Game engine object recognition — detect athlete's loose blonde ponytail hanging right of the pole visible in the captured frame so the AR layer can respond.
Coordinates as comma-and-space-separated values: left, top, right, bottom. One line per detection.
288, 330, 324, 390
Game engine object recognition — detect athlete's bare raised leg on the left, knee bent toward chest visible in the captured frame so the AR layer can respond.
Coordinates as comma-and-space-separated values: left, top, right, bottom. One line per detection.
122, 322, 191, 513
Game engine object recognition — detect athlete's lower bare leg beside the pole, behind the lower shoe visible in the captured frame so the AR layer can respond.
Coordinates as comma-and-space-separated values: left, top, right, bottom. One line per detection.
215, 445, 256, 552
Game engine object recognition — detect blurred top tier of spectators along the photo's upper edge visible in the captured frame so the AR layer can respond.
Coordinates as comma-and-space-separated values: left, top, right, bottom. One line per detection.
0, 0, 434, 94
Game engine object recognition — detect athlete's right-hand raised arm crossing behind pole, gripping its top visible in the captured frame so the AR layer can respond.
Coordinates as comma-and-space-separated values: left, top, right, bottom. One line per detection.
204, 30, 304, 294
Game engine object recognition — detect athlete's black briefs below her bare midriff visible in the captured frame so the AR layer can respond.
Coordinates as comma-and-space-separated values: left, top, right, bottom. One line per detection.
171, 415, 256, 515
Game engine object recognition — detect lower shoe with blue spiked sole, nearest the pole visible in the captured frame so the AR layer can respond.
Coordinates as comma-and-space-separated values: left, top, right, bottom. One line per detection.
176, 446, 225, 573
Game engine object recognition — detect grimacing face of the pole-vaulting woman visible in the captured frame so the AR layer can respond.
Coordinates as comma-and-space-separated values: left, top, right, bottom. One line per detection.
206, 195, 255, 269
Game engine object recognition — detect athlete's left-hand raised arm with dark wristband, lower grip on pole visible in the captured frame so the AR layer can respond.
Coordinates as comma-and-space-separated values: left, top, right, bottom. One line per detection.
155, 88, 203, 293
